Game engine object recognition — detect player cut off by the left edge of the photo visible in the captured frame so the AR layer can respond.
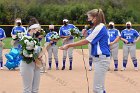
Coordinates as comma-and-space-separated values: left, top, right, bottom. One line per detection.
0, 28, 6, 69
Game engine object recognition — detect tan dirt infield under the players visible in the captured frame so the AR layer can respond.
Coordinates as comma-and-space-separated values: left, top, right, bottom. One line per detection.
0, 49, 140, 93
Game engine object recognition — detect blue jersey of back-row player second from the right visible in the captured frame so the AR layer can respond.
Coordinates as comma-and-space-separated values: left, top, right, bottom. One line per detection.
108, 28, 121, 42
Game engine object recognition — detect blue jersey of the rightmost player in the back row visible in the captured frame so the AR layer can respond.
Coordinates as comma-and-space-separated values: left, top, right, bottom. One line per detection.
121, 29, 139, 43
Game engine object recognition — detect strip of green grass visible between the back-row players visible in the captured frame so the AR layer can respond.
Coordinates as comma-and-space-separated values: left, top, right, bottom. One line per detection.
4, 38, 140, 49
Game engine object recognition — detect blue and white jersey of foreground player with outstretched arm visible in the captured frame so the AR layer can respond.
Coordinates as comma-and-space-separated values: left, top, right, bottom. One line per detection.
86, 23, 110, 56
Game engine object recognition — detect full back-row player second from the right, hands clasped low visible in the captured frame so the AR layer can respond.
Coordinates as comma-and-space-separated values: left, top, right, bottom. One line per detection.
108, 22, 121, 71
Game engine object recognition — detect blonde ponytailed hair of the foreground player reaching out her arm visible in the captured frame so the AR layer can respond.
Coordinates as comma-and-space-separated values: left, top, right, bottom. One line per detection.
87, 9, 106, 24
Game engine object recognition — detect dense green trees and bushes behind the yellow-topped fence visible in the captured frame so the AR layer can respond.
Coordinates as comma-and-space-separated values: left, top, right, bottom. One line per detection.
0, 0, 138, 36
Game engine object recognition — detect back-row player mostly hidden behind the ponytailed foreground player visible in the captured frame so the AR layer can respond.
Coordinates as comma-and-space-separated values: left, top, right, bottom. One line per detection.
82, 29, 93, 71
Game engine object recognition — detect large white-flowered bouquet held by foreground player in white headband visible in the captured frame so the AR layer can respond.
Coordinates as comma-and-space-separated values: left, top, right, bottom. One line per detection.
19, 36, 41, 64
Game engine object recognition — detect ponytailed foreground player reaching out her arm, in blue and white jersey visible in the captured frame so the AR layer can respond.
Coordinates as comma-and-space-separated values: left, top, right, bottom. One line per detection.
60, 9, 110, 93
